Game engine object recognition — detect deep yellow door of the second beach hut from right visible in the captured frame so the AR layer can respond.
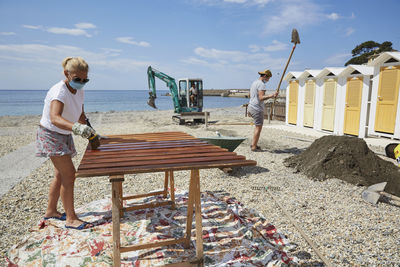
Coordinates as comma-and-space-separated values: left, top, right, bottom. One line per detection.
343, 77, 363, 136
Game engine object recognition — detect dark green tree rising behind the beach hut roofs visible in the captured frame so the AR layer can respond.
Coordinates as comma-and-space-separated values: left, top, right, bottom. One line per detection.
344, 41, 393, 66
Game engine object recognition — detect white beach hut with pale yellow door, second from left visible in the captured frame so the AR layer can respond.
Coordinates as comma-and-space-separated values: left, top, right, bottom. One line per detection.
299, 69, 321, 128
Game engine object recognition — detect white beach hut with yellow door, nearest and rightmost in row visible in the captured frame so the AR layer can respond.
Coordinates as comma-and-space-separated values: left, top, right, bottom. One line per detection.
368, 52, 400, 139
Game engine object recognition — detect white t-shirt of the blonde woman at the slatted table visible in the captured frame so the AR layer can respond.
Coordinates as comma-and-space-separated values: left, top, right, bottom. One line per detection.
40, 81, 84, 134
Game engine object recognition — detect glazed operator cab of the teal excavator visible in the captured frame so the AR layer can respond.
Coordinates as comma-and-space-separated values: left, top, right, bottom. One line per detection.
178, 78, 203, 112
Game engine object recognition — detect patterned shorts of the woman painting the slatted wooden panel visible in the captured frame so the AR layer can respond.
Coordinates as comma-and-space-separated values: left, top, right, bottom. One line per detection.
36, 126, 76, 157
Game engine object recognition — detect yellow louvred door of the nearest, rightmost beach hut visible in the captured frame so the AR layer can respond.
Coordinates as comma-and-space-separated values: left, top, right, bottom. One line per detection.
375, 66, 400, 134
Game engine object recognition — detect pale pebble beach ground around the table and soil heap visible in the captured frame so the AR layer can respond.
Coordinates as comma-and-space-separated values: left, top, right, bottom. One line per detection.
0, 107, 400, 266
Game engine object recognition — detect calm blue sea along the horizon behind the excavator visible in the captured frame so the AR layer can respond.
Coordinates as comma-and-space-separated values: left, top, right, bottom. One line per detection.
0, 90, 249, 116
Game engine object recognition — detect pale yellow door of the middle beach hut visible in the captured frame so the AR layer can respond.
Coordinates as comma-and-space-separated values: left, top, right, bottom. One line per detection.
321, 79, 336, 131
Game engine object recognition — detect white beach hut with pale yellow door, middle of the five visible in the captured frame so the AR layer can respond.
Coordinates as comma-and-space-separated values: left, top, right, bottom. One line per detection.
316, 67, 345, 134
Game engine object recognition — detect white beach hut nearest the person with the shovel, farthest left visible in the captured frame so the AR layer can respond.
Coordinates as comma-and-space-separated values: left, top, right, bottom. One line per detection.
284, 71, 302, 125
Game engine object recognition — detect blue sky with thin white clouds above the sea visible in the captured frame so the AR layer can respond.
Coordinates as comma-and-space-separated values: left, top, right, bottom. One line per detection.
0, 0, 400, 90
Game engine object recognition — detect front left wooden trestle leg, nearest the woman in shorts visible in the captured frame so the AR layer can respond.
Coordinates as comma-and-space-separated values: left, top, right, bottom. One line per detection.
110, 175, 124, 267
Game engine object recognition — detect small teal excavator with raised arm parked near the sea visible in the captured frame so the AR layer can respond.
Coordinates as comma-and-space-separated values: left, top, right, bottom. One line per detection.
147, 66, 209, 124
